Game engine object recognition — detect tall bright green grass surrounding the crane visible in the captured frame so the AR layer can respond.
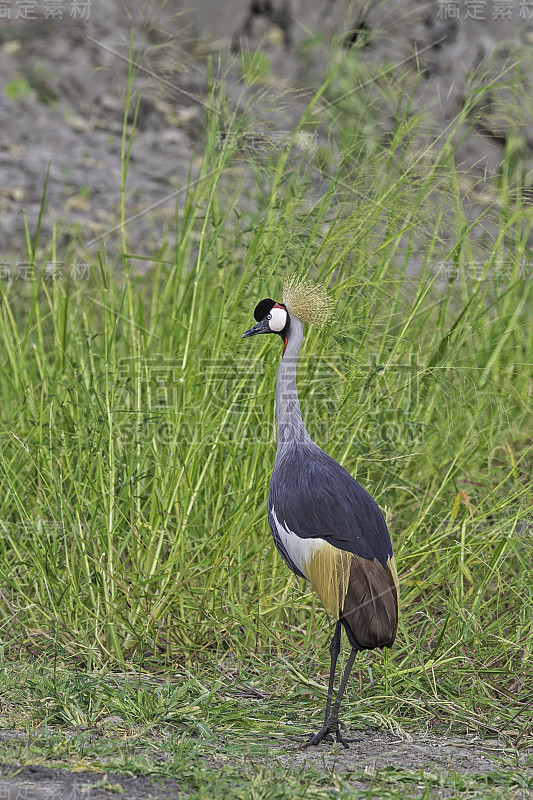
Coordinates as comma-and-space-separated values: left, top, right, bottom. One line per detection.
0, 34, 533, 797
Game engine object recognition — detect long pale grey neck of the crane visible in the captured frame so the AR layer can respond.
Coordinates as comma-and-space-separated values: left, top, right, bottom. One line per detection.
276, 317, 310, 453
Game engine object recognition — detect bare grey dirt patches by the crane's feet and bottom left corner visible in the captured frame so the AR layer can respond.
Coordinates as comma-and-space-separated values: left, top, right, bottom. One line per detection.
0, 729, 533, 800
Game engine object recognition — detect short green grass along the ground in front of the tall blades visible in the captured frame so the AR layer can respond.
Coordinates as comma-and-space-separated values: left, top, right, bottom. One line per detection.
2, 661, 533, 800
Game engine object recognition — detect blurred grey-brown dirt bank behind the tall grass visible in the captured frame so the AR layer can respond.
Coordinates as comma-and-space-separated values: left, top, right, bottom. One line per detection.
0, 0, 533, 260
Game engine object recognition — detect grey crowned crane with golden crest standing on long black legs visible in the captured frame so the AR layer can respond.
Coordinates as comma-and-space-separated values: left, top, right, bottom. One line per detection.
242, 276, 399, 747
